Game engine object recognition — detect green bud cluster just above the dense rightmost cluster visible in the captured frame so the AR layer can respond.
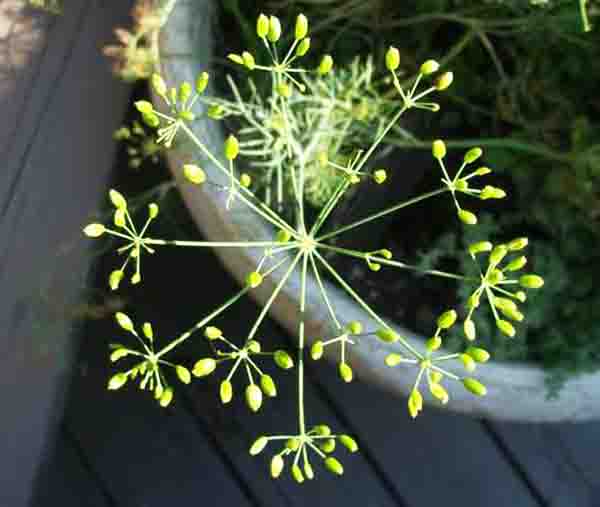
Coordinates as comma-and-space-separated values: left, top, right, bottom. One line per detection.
431, 139, 506, 225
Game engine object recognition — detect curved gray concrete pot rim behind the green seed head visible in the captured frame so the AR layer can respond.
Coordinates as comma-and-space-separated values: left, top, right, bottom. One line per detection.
161, 0, 600, 422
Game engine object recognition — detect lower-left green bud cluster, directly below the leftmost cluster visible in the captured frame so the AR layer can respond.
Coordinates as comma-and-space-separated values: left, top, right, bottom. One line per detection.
108, 312, 192, 407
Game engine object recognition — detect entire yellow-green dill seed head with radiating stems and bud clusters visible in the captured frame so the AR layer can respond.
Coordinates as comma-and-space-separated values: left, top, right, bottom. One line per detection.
84, 14, 543, 483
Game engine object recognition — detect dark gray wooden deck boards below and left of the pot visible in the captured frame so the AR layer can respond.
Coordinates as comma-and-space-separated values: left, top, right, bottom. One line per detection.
0, 0, 600, 507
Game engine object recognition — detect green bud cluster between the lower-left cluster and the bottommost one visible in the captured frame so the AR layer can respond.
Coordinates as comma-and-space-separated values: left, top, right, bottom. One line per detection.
192, 326, 294, 412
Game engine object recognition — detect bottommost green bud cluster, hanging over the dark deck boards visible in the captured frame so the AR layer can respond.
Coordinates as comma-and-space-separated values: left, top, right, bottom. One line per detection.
250, 424, 358, 483
